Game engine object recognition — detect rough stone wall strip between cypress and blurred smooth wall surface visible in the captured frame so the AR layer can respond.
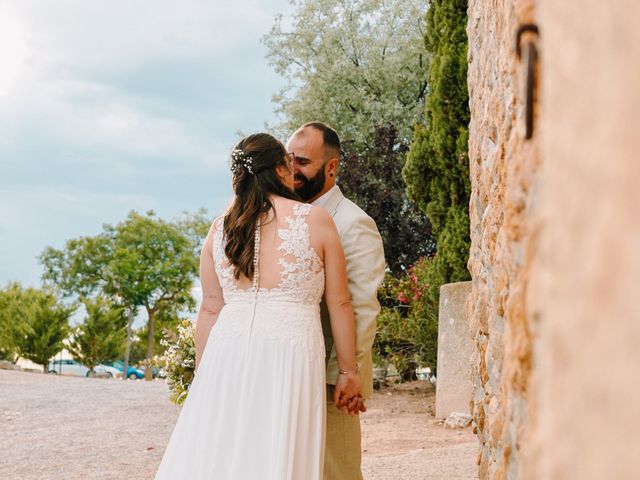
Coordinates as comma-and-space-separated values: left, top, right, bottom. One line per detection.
467, 0, 540, 479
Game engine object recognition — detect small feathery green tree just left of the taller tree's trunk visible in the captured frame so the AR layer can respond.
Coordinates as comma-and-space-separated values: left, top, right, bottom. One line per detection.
67, 296, 127, 372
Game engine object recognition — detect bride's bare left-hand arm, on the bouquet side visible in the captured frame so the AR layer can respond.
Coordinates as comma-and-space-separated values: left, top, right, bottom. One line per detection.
196, 225, 224, 370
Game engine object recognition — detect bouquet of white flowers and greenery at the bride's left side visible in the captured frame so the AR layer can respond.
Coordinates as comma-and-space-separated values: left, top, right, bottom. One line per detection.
153, 320, 196, 405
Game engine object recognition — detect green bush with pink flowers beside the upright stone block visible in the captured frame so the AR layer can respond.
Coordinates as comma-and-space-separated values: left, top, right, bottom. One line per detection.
373, 257, 438, 380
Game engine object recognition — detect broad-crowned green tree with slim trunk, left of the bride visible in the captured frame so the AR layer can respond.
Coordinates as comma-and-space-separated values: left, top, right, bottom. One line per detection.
40, 212, 208, 379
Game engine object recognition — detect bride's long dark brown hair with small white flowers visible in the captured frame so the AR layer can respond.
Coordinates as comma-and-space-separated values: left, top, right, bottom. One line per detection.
223, 133, 299, 280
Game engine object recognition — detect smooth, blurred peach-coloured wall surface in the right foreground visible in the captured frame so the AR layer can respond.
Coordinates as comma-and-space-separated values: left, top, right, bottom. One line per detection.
523, 0, 640, 480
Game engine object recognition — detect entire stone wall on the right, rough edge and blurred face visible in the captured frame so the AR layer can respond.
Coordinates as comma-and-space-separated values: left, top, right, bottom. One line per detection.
468, 0, 640, 480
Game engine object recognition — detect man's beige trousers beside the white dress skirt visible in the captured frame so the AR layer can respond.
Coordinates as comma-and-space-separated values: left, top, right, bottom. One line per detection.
324, 385, 362, 480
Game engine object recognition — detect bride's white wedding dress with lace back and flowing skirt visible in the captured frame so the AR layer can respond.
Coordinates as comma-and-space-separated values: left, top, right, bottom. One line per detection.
155, 203, 326, 480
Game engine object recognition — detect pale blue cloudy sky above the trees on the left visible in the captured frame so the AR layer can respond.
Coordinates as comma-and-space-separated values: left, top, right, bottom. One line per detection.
0, 0, 292, 287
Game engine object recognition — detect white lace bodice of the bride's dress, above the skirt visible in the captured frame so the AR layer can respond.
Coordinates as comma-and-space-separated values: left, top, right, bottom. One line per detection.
213, 203, 324, 304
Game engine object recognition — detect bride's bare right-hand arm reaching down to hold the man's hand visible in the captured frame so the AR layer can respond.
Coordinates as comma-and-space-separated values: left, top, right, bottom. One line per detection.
317, 209, 361, 406
